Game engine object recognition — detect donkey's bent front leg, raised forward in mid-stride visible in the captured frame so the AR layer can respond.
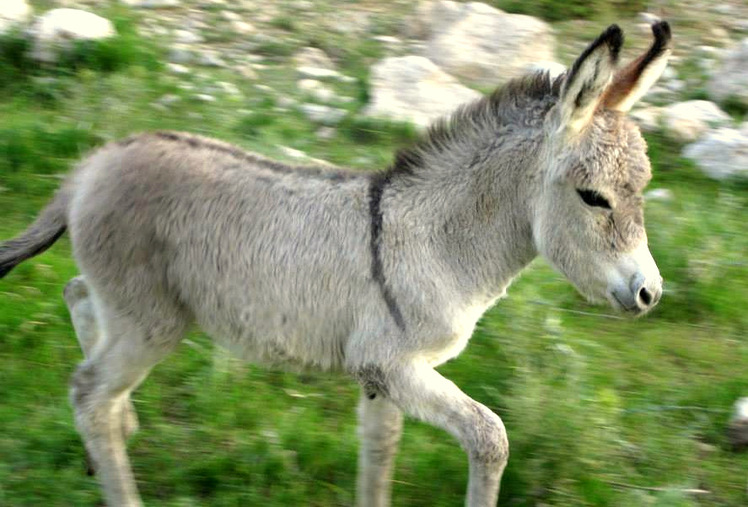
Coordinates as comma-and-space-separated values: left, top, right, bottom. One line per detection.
385, 365, 509, 507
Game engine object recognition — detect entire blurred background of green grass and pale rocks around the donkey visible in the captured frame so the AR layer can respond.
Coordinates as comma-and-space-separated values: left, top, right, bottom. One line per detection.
0, 0, 748, 506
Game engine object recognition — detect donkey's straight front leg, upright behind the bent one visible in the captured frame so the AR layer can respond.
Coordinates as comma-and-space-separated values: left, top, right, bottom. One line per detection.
356, 390, 403, 507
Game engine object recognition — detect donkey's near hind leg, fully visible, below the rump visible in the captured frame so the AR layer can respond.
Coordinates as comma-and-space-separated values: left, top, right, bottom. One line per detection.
70, 300, 186, 506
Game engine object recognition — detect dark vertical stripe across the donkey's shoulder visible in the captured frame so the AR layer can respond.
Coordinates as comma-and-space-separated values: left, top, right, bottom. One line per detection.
369, 172, 405, 331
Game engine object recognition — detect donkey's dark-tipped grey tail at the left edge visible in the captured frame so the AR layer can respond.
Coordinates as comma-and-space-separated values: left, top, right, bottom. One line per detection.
0, 187, 70, 278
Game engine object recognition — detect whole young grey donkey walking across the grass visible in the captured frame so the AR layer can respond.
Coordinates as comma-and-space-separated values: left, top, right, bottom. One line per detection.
0, 23, 670, 507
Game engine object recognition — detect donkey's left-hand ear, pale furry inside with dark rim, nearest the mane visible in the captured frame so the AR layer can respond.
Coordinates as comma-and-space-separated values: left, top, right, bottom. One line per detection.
559, 25, 623, 134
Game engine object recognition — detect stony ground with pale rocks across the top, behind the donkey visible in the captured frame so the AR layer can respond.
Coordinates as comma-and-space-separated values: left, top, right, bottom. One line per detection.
0, 0, 748, 179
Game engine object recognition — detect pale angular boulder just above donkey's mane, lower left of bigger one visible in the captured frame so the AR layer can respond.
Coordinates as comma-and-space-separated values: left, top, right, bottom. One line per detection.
365, 56, 481, 127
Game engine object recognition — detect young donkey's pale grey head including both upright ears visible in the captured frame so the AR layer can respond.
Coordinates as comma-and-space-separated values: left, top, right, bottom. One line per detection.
533, 22, 670, 314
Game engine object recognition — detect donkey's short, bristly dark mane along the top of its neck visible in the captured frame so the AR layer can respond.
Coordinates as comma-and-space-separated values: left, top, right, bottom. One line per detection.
383, 71, 566, 181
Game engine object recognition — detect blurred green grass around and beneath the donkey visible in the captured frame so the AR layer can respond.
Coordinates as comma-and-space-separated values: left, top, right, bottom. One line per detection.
0, 0, 748, 507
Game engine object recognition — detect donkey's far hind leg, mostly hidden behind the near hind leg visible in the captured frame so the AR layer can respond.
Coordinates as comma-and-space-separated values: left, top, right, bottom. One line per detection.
63, 276, 138, 440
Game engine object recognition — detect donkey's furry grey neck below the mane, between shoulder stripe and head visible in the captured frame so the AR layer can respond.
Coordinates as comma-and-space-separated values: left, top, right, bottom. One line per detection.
382, 125, 542, 301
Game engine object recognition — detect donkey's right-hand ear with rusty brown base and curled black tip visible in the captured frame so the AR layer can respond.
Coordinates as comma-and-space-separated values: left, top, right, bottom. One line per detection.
603, 21, 672, 113
